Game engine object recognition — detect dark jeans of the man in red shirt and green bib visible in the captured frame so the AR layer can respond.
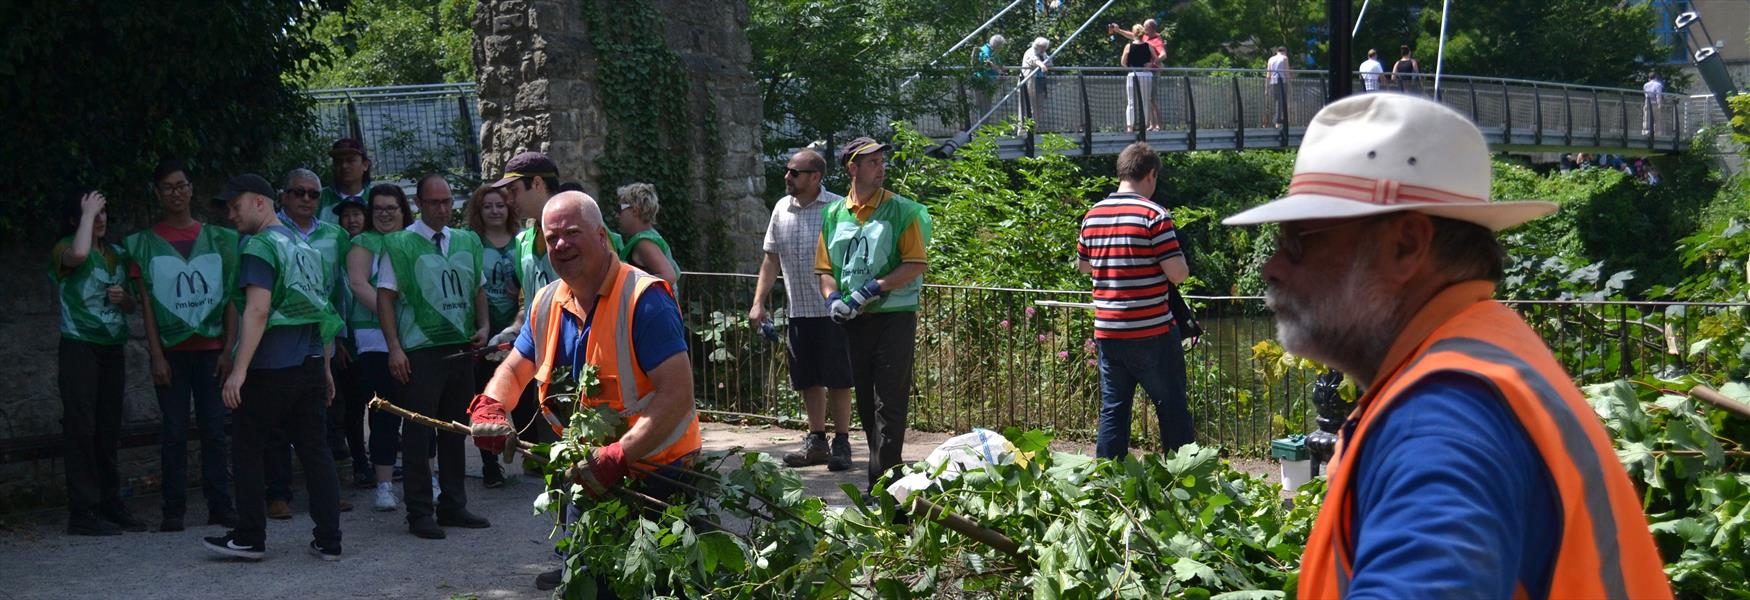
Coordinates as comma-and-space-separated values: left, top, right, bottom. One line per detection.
156, 350, 231, 516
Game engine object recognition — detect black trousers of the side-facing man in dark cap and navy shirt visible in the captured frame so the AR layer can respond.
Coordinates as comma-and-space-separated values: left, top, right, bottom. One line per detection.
231, 357, 340, 546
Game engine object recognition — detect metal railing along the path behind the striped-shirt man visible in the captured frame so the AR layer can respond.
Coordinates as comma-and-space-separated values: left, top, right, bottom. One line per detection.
683, 273, 1750, 455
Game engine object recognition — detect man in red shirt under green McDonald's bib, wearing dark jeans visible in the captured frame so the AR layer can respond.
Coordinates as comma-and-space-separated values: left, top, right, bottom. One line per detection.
123, 161, 238, 532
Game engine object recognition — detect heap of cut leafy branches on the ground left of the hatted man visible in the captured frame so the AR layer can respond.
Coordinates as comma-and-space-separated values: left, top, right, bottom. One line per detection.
534, 376, 1323, 598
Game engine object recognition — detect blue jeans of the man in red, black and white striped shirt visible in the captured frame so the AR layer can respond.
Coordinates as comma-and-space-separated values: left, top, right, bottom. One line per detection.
1094, 329, 1197, 458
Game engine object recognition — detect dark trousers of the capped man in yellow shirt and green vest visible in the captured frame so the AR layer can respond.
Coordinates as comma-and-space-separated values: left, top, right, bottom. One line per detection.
845, 311, 917, 486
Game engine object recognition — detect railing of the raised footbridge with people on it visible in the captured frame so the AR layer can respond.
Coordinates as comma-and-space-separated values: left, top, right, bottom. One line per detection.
917, 66, 1720, 154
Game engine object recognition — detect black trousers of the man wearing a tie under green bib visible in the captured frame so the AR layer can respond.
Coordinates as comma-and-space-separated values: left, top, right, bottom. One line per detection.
396, 345, 474, 523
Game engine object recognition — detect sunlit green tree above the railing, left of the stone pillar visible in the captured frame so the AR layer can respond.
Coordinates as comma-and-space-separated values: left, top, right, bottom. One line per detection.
301, 0, 474, 87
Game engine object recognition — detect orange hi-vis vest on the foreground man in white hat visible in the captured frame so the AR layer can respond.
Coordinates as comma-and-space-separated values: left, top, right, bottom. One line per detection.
1299, 282, 1671, 598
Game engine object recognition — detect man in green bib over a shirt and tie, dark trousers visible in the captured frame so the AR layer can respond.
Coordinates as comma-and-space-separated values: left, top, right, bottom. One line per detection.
376, 175, 492, 539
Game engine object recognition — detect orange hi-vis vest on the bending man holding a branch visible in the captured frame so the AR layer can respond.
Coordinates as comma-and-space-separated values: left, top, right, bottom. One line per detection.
529, 262, 700, 476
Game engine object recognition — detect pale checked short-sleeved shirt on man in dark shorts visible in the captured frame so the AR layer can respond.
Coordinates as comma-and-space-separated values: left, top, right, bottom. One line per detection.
765, 189, 844, 318
